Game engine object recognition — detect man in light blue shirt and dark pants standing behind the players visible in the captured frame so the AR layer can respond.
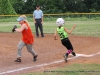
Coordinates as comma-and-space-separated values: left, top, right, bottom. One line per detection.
33, 5, 44, 37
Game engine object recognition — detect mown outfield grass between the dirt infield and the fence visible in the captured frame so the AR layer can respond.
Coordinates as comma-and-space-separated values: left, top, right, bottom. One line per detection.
0, 20, 100, 37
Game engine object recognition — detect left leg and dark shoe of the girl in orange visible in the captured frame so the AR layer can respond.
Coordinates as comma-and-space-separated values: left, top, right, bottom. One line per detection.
15, 40, 25, 62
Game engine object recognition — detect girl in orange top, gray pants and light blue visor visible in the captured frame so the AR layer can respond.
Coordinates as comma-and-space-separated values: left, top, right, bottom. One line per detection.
12, 15, 37, 62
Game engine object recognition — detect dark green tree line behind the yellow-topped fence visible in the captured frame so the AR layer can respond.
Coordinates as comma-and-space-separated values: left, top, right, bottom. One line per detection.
0, 0, 100, 14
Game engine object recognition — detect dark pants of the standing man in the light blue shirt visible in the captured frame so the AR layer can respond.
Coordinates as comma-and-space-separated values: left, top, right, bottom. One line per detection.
35, 19, 44, 37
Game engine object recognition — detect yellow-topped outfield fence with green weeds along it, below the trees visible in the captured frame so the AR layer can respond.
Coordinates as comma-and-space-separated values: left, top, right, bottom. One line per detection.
0, 13, 100, 22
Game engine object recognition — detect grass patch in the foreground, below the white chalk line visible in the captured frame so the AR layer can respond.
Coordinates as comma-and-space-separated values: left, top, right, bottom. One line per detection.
22, 64, 100, 75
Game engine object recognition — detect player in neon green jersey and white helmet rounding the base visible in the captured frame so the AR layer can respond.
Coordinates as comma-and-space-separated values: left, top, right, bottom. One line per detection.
54, 18, 76, 61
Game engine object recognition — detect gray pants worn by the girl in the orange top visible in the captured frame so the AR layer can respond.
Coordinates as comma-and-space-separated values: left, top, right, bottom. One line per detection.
18, 40, 36, 57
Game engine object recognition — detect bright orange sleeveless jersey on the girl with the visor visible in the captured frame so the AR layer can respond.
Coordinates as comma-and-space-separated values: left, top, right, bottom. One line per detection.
22, 23, 34, 44
